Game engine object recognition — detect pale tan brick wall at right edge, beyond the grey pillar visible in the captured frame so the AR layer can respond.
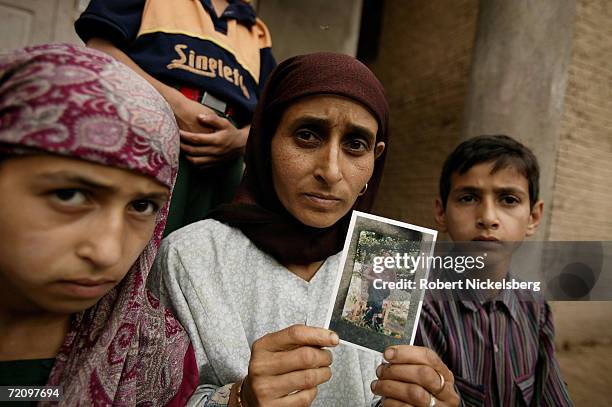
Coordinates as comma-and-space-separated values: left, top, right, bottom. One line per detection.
549, 0, 612, 240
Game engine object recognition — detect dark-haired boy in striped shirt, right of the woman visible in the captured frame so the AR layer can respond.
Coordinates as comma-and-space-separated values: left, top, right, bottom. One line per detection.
416, 136, 572, 407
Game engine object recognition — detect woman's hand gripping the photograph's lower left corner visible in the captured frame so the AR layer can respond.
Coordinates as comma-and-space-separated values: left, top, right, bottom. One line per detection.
241, 325, 338, 407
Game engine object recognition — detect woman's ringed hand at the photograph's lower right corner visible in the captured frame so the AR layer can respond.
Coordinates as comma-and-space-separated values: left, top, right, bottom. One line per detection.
372, 345, 460, 407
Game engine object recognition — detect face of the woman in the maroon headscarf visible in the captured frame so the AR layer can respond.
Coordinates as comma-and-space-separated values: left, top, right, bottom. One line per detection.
272, 95, 385, 228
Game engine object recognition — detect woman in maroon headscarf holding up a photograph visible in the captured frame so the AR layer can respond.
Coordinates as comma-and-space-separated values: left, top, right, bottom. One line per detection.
151, 53, 454, 407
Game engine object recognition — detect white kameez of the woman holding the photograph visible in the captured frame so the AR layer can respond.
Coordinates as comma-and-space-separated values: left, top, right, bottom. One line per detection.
149, 220, 382, 407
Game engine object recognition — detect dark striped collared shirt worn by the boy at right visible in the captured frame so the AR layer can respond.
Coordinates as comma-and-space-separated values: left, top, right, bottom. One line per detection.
415, 290, 573, 407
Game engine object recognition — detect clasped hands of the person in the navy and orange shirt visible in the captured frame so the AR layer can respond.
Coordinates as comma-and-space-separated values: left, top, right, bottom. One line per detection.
181, 113, 249, 168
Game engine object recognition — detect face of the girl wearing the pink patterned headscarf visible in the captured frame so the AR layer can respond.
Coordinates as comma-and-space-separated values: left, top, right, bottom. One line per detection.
0, 155, 169, 314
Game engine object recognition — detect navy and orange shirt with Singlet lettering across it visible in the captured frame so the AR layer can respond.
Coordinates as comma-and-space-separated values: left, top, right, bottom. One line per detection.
75, 0, 276, 124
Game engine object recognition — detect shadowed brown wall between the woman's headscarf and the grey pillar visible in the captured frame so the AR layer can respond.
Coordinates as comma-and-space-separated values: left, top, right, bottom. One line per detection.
370, 0, 478, 236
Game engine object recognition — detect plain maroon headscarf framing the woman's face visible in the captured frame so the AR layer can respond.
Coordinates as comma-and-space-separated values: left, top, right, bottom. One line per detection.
210, 52, 389, 264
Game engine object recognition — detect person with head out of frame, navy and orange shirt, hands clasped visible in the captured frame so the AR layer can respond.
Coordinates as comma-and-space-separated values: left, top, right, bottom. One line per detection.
75, 0, 276, 235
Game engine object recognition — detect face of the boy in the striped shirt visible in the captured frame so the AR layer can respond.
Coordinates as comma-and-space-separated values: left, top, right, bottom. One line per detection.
436, 162, 543, 246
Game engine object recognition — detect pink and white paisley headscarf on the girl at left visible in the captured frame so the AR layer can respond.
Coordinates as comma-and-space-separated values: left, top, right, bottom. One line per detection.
0, 44, 195, 406
